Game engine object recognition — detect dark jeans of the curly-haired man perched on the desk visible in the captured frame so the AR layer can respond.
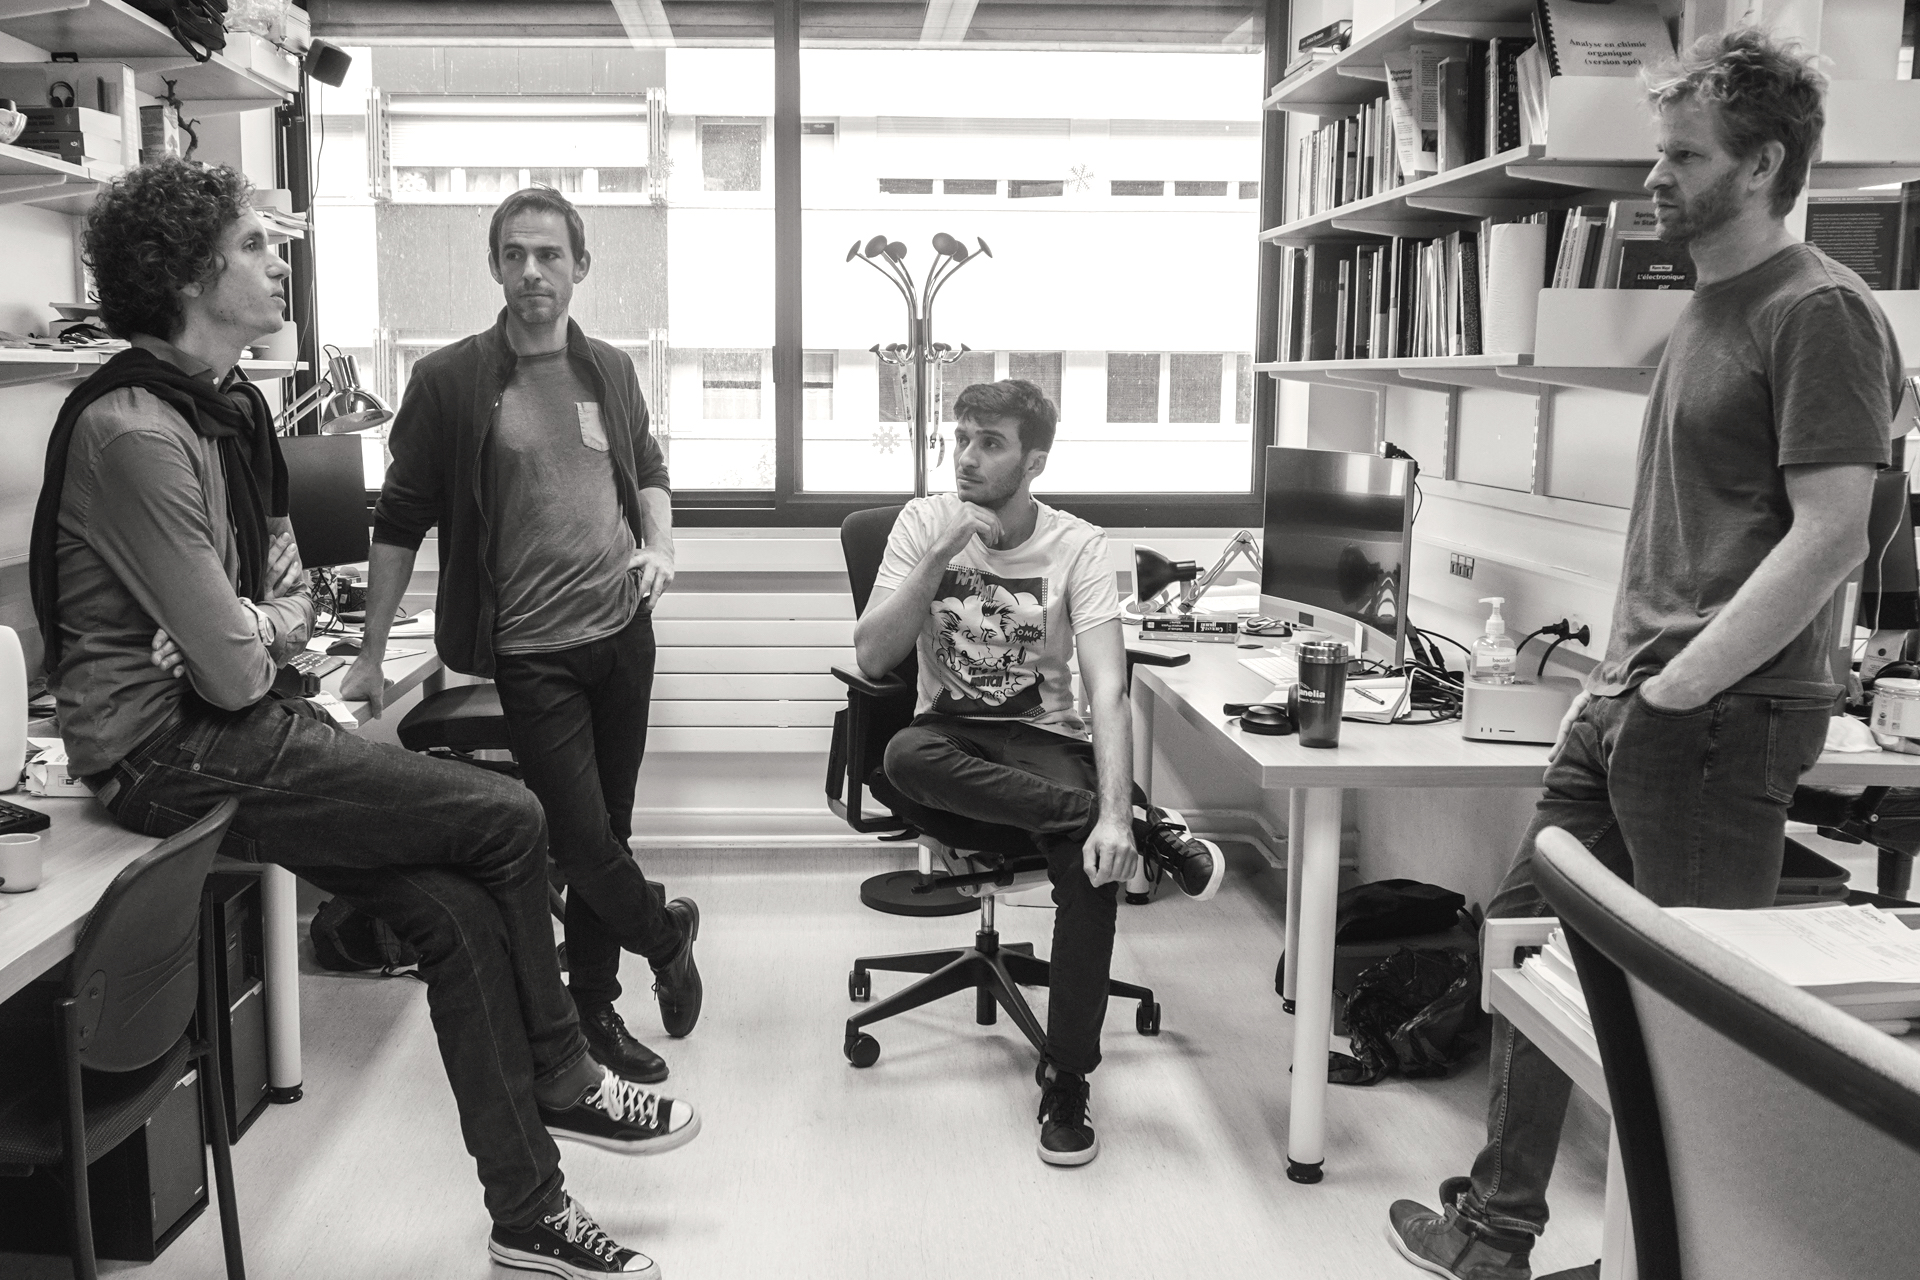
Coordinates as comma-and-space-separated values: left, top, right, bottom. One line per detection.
88, 699, 588, 1222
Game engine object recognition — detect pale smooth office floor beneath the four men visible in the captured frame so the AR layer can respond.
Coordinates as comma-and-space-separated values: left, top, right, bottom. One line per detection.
0, 848, 1605, 1280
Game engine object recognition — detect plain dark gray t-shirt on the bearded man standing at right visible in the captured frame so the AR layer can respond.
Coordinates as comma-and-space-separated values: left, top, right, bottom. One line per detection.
1588, 244, 1901, 697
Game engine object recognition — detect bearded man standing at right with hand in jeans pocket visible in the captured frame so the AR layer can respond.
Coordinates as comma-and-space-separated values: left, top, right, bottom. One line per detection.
1390, 31, 1901, 1280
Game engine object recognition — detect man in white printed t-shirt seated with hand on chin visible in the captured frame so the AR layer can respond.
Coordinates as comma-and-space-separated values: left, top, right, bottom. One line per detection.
852, 380, 1223, 1165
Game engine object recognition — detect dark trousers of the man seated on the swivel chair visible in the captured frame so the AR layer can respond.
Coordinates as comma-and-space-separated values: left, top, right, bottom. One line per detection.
885, 716, 1119, 1075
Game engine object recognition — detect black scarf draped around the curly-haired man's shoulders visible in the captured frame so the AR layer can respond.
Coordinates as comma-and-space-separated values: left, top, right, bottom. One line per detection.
29, 347, 286, 674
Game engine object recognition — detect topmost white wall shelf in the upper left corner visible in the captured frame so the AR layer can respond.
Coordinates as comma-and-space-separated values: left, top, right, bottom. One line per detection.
0, 0, 300, 115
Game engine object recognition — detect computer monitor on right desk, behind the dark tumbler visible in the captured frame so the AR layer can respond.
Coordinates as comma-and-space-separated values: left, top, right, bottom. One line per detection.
1260, 445, 1417, 666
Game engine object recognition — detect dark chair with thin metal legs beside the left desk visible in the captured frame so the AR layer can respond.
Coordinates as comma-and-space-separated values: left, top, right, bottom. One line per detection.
0, 798, 246, 1280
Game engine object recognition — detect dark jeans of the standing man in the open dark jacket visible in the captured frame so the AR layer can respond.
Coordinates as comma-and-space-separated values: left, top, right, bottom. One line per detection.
493, 610, 685, 1009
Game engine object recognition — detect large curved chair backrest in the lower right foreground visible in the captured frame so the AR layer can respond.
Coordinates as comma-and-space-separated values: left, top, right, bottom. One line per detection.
1536, 827, 1920, 1280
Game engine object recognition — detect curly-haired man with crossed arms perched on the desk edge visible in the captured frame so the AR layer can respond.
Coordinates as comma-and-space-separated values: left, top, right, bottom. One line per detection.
31, 159, 699, 1278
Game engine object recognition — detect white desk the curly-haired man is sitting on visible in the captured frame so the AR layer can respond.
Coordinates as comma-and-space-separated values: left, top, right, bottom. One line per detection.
0, 637, 442, 1102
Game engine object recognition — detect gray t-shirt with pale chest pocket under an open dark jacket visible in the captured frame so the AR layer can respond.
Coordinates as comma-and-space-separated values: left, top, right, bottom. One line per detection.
486, 349, 639, 652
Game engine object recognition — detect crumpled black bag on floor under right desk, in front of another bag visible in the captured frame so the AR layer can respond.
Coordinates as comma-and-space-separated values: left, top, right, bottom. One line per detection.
1327, 946, 1480, 1084
